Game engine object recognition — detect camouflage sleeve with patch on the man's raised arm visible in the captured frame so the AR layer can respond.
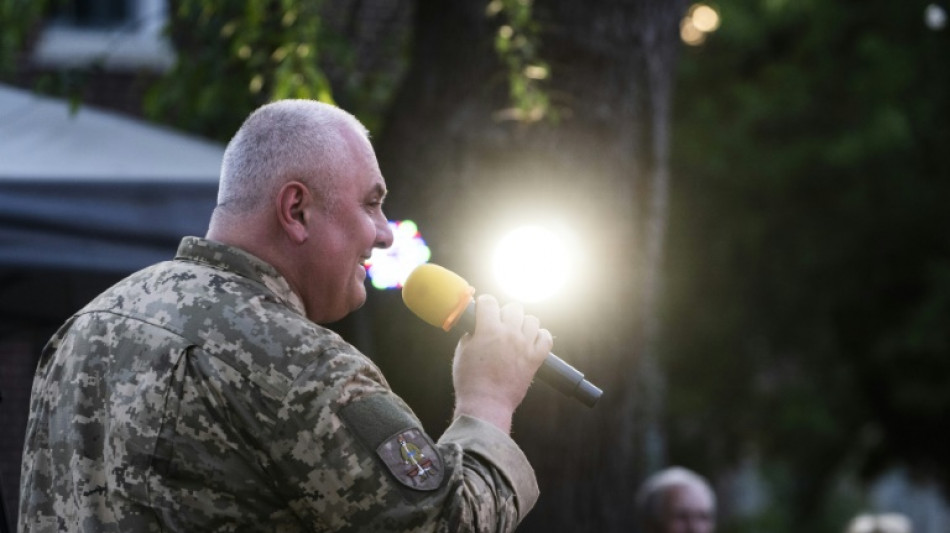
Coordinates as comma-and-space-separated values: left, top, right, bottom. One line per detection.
270, 342, 538, 532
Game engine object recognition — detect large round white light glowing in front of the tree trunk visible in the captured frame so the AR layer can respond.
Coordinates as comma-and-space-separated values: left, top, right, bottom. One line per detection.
494, 222, 572, 302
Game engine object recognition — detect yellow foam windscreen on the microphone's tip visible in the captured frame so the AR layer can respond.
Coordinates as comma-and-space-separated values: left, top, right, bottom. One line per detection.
402, 263, 475, 331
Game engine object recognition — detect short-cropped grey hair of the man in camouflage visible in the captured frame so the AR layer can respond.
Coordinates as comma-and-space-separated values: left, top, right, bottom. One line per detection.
217, 100, 369, 213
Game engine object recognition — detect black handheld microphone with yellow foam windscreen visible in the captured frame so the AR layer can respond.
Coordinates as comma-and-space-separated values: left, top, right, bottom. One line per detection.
402, 263, 604, 407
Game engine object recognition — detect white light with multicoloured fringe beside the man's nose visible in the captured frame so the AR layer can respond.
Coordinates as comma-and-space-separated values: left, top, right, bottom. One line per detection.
366, 220, 432, 289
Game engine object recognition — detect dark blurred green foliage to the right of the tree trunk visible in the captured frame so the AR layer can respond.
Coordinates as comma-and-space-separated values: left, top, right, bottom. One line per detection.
667, 0, 950, 531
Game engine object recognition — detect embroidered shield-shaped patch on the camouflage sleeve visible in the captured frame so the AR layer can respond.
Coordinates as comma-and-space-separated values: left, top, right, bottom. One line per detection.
376, 428, 444, 490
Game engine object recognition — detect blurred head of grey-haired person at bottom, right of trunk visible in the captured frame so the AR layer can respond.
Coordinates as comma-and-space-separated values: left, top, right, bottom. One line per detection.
636, 466, 716, 533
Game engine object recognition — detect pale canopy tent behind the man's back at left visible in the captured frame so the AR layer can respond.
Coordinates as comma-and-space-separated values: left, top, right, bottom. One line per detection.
0, 85, 224, 321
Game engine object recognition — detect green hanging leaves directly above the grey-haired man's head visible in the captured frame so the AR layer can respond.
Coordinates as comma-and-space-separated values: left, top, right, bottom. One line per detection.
146, 0, 333, 140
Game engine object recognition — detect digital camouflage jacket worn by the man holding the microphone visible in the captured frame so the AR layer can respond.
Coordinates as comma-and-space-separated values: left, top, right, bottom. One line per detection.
19, 237, 538, 533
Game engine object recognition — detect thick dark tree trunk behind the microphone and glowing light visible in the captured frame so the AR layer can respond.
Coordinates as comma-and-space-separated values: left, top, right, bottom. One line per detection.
378, 0, 683, 531
